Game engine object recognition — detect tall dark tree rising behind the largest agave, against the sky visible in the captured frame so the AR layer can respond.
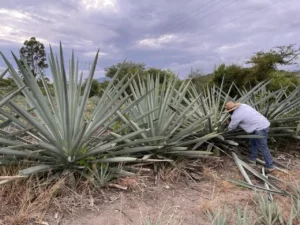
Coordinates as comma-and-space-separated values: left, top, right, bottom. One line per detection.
20, 37, 48, 77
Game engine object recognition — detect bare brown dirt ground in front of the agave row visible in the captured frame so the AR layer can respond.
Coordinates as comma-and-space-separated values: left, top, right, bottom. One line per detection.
42, 155, 300, 225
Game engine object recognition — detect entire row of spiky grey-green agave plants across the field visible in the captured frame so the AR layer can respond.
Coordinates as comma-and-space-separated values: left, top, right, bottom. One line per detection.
0, 46, 300, 193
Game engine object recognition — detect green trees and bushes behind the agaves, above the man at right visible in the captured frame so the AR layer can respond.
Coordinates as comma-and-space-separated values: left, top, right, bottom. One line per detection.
212, 45, 300, 96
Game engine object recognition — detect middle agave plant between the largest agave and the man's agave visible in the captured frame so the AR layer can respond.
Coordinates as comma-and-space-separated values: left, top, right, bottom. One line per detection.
106, 75, 218, 157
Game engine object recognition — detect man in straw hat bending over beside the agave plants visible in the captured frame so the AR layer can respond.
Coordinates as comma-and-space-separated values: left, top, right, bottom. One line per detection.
225, 101, 275, 173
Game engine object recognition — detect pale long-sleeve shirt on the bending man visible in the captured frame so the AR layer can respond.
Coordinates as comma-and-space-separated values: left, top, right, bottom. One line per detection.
228, 104, 270, 133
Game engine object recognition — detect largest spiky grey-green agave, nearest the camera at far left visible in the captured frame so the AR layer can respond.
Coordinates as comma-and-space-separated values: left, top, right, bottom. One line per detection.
0, 45, 170, 183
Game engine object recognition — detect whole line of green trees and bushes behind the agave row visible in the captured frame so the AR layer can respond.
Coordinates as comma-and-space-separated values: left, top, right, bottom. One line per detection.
0, 37, 300, 97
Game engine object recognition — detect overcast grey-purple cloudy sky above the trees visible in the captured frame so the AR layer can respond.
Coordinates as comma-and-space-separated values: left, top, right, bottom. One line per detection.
0, 0, 300, 78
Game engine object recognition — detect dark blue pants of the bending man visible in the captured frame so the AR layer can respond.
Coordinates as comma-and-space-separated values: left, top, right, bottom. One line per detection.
250, 128, 274, 168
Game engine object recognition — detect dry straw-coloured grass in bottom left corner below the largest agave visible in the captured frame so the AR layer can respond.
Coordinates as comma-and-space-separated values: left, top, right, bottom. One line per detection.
0, 166, 98, 225
